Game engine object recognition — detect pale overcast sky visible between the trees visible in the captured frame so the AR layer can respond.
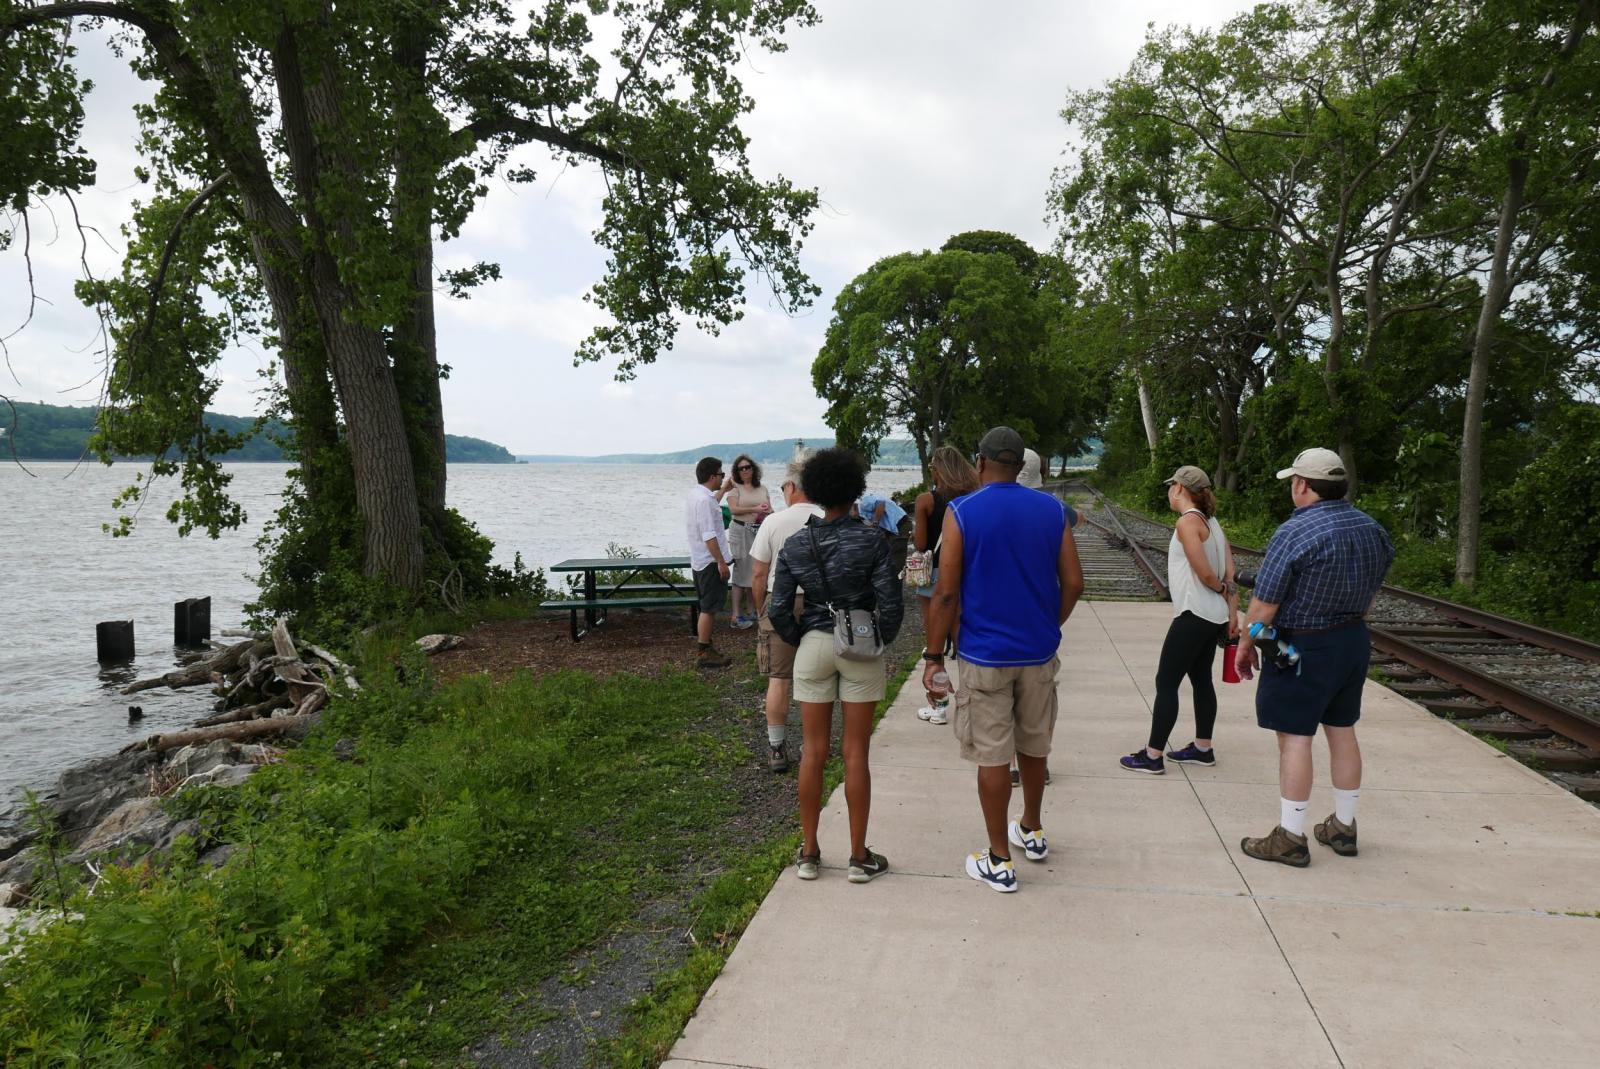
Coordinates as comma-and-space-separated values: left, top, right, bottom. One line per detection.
0, 0, 1251, 454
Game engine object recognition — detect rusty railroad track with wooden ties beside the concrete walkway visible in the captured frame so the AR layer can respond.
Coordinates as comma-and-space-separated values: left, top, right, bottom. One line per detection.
1053, 483, 1600, 802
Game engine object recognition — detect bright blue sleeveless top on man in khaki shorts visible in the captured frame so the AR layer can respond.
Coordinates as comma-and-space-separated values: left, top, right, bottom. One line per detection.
950, 483, 1067, 667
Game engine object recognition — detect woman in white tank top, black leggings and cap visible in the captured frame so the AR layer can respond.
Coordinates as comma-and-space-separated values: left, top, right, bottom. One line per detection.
1122, 464, 1238, 776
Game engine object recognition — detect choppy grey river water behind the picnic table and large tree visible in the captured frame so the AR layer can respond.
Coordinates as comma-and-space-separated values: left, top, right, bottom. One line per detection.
0, 462, 917, 815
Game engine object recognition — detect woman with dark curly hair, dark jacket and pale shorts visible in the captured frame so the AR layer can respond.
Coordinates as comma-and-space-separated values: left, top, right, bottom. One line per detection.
766, 448, 904, 883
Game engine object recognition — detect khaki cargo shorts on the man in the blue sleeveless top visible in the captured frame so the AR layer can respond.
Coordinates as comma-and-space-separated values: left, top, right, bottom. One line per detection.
950, 658, 1061, 765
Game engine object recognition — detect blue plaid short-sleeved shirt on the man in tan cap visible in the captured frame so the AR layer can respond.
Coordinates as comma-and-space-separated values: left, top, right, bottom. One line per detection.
1256, 499, 1395, 631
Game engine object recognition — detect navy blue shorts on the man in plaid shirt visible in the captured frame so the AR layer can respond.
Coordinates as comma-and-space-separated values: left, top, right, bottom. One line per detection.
1256, 623, 1373, 735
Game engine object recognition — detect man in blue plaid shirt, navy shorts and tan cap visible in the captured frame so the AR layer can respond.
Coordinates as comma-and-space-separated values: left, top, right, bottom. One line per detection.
1235, 450, 1395, 867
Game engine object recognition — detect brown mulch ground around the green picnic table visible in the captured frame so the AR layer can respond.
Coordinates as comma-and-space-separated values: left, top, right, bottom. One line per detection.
432, 608, 755, 680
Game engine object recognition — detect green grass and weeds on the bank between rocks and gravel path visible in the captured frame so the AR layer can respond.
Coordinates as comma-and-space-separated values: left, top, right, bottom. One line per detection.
0, 662, 734, 1066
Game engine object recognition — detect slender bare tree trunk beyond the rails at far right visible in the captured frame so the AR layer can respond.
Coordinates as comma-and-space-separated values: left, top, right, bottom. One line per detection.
1456, 155, 1528, 587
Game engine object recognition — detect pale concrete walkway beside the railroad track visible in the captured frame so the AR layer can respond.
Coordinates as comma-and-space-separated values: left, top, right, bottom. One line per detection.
667, 603, 1600, 1069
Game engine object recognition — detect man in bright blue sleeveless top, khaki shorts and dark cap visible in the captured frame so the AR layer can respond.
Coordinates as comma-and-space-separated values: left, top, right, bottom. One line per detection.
922, 427, 1083, 891
